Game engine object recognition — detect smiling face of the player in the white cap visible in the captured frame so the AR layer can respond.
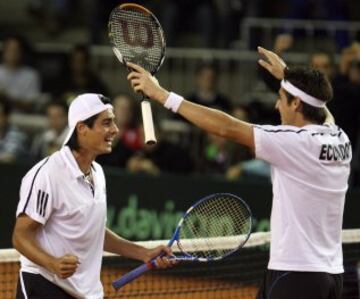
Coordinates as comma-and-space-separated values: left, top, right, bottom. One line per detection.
77, 109, 119, 156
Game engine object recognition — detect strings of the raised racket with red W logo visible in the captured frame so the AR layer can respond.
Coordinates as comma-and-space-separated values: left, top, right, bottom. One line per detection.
108, 6, 165, 74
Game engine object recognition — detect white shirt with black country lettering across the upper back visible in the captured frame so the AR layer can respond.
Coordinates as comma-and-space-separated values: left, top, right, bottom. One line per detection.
254, 125, 352, 274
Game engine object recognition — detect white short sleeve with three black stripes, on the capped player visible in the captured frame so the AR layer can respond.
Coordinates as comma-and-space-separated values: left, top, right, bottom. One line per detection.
16, 159, 53, 224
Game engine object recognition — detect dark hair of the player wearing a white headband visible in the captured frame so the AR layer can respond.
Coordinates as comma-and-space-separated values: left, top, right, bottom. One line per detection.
284, 67, 333, 124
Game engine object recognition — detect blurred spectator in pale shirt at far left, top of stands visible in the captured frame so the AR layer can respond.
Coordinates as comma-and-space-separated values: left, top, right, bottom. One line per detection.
0, 35, 40, 112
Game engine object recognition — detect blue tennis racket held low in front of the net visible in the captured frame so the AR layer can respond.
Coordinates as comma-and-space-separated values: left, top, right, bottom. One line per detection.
113, 193, 252, 289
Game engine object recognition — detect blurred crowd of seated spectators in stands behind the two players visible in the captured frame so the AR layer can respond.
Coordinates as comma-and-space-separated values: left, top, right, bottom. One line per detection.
0, 25, 360, 185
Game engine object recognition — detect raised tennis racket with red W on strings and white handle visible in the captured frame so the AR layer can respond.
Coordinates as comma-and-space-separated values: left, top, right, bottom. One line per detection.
108, 3, 166, 144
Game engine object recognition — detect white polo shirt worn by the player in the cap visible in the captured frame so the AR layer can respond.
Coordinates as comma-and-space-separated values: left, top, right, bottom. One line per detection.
16, 146, 106, 299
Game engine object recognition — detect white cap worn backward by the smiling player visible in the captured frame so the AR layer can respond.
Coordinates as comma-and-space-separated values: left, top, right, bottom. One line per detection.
63, 93, 113, 146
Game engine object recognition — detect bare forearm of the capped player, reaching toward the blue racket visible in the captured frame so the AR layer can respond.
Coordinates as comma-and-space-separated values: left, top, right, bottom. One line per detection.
104, 229, 146, 261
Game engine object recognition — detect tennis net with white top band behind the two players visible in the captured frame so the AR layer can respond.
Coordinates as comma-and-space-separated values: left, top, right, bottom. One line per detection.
0, 229, 360, 299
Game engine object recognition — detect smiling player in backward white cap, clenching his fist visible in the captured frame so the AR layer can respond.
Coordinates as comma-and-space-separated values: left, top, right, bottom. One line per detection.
13, 94, 172, 299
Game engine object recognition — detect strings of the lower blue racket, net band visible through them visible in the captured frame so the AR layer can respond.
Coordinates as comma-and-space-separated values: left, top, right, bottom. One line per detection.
178, 194, 251, 259
